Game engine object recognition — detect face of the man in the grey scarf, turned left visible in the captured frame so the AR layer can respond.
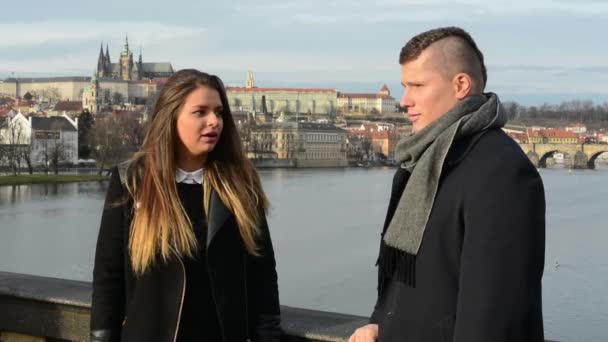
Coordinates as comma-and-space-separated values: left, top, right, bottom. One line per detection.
400, 49, 458, 132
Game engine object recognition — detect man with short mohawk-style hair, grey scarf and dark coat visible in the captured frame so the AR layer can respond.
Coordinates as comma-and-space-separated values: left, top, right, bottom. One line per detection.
350, 27, 545, 342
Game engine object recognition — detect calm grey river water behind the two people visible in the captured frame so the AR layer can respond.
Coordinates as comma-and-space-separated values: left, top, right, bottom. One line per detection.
0, 169, 608, 341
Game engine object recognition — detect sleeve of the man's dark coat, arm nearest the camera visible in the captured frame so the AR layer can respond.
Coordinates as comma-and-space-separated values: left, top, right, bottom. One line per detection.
454, 155, 545, 342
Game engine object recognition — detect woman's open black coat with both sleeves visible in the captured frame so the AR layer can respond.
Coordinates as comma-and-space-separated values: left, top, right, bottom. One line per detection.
91, 168, 281, 342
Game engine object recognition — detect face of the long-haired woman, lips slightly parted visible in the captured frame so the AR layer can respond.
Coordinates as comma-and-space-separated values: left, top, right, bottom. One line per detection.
176, 86, 224, 161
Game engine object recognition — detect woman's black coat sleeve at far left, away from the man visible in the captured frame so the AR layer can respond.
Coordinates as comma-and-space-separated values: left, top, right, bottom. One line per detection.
91, 168, 125, 342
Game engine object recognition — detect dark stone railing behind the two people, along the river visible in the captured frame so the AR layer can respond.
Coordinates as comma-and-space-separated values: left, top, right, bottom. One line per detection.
0, 272, 560, 342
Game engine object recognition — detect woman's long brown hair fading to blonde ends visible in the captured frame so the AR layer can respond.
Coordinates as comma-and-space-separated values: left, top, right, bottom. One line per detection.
125, 69, 268, 274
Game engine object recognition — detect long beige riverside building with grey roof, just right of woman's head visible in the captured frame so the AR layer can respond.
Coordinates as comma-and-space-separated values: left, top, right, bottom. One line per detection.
247, 122, 347, 167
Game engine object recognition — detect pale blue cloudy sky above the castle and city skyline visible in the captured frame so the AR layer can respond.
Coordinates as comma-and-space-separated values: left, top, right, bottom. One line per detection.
0, 0, 608, 105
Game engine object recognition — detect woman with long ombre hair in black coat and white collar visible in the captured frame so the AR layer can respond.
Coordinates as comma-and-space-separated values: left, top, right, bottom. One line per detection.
91, 70, 280, 342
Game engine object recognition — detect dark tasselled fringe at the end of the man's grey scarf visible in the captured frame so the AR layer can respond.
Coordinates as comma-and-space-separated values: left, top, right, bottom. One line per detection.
376, 240, 416, 293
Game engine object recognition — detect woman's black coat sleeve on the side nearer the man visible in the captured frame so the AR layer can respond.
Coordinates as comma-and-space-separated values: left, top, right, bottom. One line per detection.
247, 212, 281, 342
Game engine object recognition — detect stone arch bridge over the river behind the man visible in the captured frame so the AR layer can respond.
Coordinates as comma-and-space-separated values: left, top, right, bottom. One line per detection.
519, 143, 608, 169
